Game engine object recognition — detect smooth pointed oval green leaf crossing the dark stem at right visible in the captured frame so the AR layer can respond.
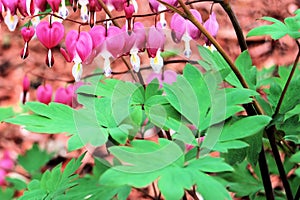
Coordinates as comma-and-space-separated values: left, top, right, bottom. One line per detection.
220, 115, 272, 141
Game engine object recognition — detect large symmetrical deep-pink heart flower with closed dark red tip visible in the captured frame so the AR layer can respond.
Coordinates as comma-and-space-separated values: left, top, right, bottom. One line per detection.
36, 21, 64, 67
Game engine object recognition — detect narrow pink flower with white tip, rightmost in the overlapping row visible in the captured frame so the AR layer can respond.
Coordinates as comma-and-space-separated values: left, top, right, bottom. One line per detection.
146, 24, 166, 73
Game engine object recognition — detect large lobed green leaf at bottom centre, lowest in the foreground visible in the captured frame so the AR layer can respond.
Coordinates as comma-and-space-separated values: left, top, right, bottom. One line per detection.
100, 139, 232, 199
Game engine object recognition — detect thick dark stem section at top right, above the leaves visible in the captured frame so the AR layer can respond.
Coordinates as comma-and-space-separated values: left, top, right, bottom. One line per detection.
219, 1, 248, 52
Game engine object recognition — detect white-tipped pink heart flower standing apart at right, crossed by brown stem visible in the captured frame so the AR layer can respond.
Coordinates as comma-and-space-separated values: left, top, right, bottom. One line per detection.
170, 9, 202, 58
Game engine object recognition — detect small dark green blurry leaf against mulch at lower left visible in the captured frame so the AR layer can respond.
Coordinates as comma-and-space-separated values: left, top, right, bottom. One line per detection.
17, 144, 53, 174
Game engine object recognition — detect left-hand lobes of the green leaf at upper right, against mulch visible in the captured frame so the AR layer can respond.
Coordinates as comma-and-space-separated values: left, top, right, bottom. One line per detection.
247, 17, 288, 40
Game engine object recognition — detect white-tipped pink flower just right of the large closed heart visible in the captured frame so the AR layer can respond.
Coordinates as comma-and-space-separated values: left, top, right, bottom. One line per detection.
61, 30, 93, 81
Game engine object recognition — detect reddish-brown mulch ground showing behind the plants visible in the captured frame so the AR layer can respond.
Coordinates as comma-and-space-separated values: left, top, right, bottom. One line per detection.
0, 0, 300, 199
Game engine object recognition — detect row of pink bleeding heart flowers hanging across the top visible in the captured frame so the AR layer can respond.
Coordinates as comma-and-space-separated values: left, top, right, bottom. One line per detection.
0, 0, 218, 81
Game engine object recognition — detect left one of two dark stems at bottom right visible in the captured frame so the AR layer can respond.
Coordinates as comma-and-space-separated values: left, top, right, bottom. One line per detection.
258, 148, 275, 200
